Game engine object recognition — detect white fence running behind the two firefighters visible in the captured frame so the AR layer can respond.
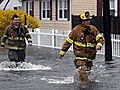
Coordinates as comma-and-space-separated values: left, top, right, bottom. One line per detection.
30, 29, 120, 57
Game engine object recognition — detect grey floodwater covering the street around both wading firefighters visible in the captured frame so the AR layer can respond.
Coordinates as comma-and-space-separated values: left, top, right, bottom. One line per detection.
0, 46, 120, 90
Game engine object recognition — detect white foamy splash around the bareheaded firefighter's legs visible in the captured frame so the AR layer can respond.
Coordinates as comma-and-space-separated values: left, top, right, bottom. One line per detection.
0, 61, 51, 71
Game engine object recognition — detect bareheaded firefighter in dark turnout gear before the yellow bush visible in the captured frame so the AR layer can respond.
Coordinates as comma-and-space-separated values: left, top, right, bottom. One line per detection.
1, 15, 32, 62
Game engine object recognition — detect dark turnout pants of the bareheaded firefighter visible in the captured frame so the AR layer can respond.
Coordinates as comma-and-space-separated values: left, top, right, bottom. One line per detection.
8, 49, 25, 62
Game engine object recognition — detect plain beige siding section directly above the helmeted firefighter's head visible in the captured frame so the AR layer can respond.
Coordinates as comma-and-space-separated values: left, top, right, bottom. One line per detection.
71, 0, 97, 16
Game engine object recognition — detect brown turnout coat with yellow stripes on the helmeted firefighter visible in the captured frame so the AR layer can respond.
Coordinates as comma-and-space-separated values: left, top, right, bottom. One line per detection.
60, 24, 104, 60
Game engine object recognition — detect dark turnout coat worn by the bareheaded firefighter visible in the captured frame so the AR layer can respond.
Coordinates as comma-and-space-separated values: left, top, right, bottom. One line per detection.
1, 23, 32, 50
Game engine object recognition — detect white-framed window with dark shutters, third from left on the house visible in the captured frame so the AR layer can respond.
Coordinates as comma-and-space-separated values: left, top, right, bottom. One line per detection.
57, 0, 69, 20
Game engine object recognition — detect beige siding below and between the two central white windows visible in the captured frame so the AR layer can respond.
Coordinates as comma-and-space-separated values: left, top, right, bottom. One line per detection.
38, 0, 71, 30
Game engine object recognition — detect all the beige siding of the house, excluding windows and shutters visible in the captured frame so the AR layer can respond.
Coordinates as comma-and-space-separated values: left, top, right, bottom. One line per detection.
23, 0, 97, 30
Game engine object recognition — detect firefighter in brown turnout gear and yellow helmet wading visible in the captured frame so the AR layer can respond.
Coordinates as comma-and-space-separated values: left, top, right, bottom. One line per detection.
59, 12, 104, 83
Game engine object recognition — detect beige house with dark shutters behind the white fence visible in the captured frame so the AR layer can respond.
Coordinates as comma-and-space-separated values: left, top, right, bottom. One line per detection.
22, 0, 120, 30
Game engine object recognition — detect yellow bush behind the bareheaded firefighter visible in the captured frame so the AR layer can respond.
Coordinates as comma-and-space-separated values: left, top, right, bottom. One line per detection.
0, 10, 39, 36
